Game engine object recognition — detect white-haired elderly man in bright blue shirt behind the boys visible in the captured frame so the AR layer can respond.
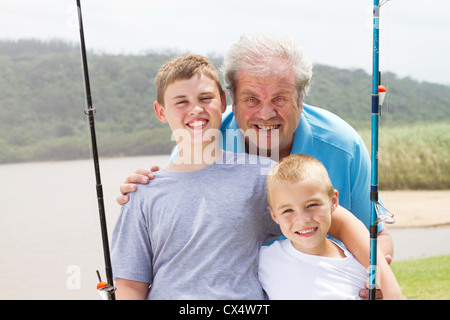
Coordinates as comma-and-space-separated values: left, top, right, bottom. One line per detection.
117, 35, 393, 262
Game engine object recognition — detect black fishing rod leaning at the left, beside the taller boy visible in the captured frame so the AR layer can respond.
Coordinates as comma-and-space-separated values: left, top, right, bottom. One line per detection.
77, 0, 115, 300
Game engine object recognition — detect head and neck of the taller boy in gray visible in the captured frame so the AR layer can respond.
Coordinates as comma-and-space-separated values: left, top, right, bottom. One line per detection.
154, 56, 226, 171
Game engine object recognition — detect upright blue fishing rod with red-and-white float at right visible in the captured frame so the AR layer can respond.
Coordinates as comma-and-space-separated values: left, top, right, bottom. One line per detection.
369, 0, 394, 300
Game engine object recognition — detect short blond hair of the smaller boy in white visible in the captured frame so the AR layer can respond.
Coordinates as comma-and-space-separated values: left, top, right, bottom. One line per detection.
267, 153, 334, 205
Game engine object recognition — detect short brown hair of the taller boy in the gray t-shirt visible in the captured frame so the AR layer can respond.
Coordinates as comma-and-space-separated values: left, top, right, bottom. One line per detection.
155, 54, 223, 106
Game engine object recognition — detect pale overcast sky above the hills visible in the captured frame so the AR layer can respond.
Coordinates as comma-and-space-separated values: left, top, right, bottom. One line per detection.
0, 0, 450, 85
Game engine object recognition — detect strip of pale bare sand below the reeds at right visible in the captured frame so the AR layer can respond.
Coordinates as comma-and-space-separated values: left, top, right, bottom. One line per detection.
380, 190, 450, 228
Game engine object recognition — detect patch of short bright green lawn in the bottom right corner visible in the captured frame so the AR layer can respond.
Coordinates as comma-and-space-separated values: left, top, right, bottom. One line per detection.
391, 255, 450, 300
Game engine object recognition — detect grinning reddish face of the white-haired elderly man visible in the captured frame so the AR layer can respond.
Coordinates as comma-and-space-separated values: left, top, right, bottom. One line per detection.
233, 69, 303, 159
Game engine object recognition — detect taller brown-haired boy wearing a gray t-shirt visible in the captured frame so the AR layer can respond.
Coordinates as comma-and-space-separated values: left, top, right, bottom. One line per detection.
112, 55, 281, 299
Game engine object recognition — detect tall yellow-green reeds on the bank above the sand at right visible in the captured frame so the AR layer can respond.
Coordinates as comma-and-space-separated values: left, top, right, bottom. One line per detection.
358, 122, 450, 190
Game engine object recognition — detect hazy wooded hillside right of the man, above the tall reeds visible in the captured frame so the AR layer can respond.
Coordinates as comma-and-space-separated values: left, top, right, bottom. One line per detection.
308, 65, 450, 127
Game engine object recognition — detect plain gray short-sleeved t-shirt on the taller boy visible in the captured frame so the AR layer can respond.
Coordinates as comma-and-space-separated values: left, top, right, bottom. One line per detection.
111, 152, 281, 300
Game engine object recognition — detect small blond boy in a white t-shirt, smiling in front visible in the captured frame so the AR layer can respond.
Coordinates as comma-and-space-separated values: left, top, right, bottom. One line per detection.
259, 154, 402, 300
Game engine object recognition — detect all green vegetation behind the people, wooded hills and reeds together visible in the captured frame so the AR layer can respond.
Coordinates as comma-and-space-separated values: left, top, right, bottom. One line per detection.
0, 40, 450, 189
